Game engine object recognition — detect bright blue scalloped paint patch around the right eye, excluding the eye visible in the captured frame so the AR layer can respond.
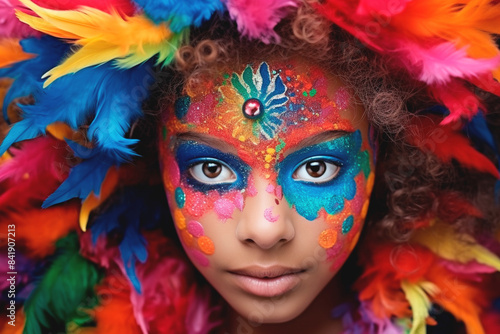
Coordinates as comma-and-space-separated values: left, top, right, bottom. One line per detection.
276, 130, 369, 220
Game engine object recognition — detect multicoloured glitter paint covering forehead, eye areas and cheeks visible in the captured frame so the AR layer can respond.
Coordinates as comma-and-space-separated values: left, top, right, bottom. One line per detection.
161, 61, 373, 274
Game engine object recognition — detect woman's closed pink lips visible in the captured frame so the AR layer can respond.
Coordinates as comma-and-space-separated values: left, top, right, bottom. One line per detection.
229, 266, 305, 298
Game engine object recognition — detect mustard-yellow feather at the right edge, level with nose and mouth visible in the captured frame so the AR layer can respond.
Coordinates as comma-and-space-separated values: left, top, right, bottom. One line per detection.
412, 222, 500, 271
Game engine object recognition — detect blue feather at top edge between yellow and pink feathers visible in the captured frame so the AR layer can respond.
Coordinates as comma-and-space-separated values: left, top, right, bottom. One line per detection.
134, 0, 224, 33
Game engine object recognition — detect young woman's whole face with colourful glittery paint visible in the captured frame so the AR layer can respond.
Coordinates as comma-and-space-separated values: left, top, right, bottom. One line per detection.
160, 60, 373, 323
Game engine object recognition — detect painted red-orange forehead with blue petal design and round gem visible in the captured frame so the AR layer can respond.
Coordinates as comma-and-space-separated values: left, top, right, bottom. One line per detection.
164, 59, 362, 150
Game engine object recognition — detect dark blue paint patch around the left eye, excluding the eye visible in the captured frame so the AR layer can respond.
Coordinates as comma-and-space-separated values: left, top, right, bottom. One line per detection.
175, 141, 250, 193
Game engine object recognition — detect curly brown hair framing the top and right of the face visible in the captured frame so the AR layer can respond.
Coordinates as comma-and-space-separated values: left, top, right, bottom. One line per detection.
143, 1, 500, 241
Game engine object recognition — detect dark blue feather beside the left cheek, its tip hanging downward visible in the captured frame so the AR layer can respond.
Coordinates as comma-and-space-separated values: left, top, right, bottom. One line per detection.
90, 186, 168, 293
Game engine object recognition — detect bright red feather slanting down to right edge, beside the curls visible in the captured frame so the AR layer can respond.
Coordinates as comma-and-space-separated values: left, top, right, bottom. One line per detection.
406, 115, 500, 178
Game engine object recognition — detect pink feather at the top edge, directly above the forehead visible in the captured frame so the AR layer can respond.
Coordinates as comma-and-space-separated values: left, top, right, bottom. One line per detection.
226, 0, 297, 44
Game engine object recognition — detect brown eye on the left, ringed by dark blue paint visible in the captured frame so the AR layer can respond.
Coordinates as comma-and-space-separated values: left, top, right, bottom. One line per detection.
189, 160, 236, 184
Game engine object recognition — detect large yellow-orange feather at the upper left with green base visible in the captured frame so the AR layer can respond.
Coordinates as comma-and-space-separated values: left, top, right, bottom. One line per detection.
17, 0, 187, 87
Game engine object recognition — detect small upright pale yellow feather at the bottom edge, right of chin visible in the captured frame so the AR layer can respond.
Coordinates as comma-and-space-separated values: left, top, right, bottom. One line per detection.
401, 280, 439, 334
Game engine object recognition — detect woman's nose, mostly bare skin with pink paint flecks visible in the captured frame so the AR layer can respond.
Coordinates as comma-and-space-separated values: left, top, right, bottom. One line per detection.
236, 176, 295, 250
